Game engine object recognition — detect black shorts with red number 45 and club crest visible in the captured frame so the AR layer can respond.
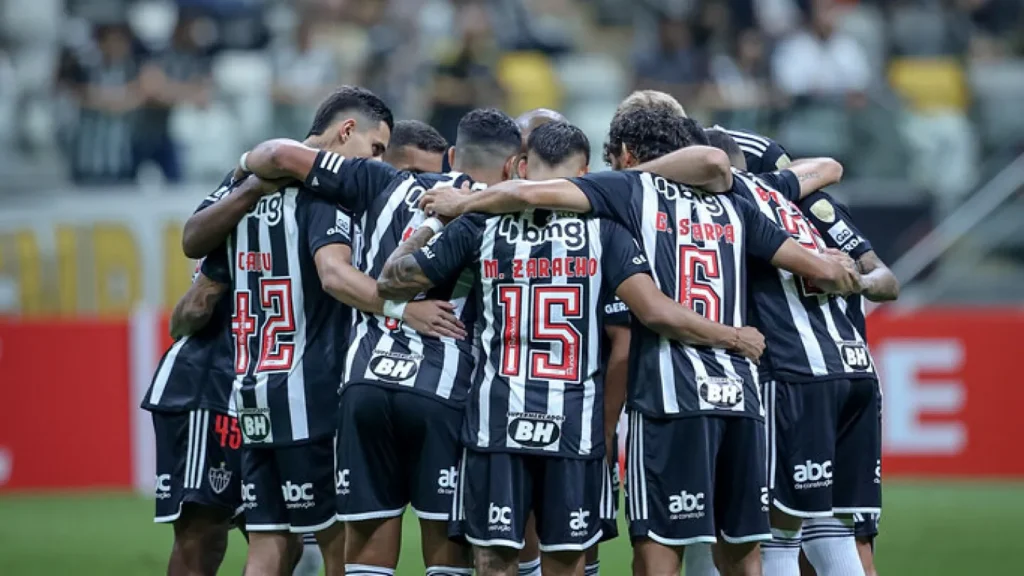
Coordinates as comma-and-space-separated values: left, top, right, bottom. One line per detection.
153, 410, 242, 523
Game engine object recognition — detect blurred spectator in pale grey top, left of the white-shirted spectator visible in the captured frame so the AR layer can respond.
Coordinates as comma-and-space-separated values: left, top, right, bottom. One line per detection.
711, 29, 774, 128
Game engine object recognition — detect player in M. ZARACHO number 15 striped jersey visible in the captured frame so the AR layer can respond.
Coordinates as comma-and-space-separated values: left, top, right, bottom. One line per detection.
378, 118, 760, 576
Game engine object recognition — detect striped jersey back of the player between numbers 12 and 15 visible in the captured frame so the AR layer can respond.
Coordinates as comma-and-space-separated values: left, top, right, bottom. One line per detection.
345, 169, 477, 406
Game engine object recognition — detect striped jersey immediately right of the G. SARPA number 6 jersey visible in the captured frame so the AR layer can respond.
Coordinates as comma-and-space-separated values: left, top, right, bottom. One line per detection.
733, 170, 874, 382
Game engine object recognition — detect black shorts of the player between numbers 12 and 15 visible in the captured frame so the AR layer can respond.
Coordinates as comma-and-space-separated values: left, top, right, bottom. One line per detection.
337, 383, 463, 522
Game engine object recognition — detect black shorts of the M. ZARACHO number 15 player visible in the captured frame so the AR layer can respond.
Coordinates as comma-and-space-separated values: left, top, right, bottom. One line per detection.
450, 450, 613, 552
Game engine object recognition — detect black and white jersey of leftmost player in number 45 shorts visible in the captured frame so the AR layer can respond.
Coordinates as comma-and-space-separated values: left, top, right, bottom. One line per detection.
142, 174, 234, 415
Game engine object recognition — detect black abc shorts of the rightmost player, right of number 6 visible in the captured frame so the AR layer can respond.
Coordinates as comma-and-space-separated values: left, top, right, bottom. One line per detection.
765, 379, 882, 518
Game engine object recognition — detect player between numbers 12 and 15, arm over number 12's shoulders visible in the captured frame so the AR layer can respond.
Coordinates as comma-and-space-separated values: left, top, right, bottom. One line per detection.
234, 109, 521, 576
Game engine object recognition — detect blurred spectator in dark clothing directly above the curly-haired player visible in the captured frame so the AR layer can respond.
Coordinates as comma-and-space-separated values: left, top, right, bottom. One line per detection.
634, 17, 708, 108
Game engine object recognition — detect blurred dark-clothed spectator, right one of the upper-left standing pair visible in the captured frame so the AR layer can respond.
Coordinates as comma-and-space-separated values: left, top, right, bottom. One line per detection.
135, 17, 211, 182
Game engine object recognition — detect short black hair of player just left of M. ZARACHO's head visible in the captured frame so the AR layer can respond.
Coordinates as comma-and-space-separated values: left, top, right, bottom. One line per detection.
455, 108, 522, 166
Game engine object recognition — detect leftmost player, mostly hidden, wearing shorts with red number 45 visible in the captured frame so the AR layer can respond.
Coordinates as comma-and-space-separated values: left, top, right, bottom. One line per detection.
142, 199, 242, 576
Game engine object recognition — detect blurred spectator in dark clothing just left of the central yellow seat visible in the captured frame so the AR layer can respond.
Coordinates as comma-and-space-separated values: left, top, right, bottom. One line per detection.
430, 0, 502, 142
